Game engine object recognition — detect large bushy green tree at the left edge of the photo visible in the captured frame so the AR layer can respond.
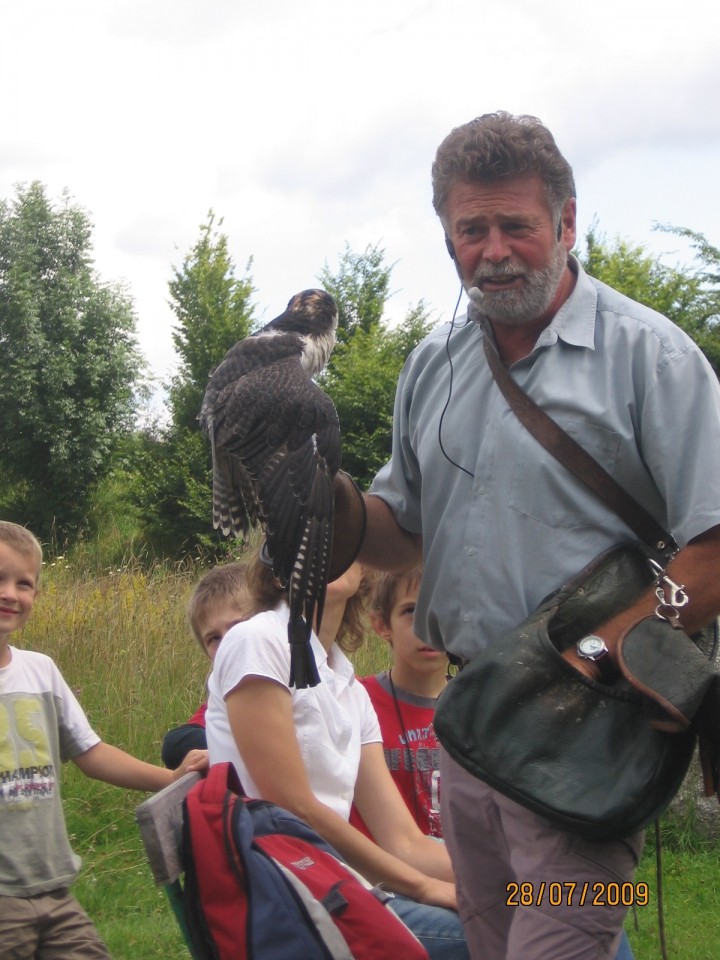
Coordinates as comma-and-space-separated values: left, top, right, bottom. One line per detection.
0, 182, 144, 542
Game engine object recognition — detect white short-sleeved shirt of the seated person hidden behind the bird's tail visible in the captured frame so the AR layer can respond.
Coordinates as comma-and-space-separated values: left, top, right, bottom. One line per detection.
205, 603, 382, 820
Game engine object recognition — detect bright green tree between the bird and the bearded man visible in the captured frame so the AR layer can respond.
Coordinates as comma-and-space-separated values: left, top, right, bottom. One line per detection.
319, 245, 431, 487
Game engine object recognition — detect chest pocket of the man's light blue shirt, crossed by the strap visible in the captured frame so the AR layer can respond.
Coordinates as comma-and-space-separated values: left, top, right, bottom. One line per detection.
508, 418, 621, 527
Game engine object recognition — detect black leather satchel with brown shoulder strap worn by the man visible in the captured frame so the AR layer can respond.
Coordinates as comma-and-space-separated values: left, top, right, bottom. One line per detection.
434, 336, 717, 840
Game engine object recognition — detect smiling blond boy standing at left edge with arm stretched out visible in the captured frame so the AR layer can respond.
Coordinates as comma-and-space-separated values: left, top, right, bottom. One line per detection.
0, 521, 207, 960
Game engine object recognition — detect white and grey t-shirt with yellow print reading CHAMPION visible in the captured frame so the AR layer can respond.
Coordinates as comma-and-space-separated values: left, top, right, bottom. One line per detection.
0, 646, 100, 897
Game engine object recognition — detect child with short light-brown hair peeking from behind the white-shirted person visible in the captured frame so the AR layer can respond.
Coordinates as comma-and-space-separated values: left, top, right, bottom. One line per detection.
160, 563, 256, 770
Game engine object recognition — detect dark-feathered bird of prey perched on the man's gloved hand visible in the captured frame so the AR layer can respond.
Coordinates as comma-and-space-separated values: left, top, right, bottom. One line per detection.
198, 290, 340, 688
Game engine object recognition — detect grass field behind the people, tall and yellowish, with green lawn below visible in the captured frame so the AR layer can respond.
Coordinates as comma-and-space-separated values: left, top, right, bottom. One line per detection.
14, 560, 720, 960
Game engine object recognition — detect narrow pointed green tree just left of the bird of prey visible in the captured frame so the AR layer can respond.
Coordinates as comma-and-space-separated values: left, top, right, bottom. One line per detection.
135, 210, 254, 555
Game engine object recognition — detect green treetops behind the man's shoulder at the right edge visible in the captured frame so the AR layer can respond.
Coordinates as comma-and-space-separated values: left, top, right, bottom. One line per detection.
579, 225, 720, 374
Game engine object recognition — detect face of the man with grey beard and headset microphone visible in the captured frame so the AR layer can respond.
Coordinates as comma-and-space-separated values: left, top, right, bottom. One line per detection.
444, 176, 576, 325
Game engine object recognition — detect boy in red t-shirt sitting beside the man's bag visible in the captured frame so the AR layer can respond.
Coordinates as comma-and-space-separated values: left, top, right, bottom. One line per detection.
350, 567, 448, 838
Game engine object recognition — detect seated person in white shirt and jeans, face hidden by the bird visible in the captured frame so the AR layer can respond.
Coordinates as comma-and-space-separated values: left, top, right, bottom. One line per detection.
207, 556, 468, 960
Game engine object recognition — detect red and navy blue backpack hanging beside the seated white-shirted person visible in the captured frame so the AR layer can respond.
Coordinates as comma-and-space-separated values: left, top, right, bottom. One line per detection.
183, 763, 428, 960
